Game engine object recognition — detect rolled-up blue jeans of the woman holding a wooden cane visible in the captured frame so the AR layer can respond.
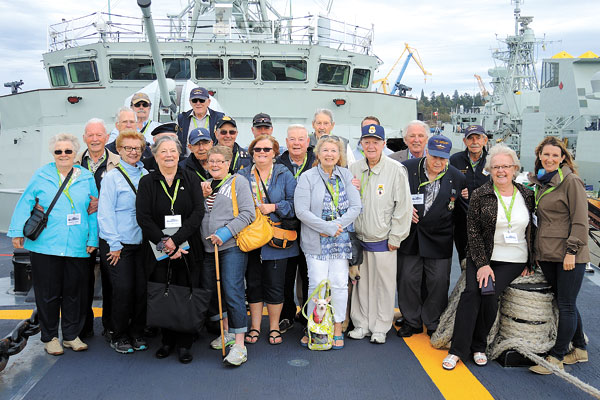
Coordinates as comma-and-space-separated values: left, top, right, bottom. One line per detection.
204, 246, 248, 333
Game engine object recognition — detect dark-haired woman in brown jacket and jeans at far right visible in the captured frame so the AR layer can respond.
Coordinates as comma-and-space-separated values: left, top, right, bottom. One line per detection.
529, 136, 590, 375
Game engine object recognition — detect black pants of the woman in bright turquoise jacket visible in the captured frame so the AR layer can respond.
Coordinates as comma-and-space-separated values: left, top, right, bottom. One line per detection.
31, 252, 88, 343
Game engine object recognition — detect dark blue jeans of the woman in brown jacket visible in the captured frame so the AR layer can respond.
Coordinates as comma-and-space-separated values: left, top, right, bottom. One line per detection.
540, 261, 585, 360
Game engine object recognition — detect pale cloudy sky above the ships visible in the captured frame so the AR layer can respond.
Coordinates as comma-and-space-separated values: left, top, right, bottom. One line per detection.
0, 0, 600, 95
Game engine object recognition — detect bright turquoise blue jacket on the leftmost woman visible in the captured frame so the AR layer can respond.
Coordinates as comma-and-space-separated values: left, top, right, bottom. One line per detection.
8, 162, 98, 258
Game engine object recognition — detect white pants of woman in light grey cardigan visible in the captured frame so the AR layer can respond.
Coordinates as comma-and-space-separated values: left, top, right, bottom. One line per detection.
306, 257, 348, 323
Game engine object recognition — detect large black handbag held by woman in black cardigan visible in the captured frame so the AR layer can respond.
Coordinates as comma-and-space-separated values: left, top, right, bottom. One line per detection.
146, 254, 212, 333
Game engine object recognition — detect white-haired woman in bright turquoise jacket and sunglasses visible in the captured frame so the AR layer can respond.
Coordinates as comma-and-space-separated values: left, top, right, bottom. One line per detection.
8, 133, 98, 355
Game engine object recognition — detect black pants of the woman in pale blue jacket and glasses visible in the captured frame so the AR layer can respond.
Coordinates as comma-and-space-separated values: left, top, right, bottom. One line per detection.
101, 244, 147, 339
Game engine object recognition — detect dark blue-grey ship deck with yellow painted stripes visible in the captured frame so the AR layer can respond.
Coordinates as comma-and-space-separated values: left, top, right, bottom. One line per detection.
0, 235, 600, 400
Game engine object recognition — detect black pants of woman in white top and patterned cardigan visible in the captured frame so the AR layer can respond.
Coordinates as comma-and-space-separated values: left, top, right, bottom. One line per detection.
448, 257, 525, 360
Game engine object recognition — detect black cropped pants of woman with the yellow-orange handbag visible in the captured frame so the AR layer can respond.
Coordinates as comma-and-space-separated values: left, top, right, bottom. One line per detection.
246, 249, 287, 304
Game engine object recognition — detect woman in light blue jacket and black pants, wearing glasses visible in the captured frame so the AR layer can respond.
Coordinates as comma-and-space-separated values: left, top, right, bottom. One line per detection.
98, 130, 148, 354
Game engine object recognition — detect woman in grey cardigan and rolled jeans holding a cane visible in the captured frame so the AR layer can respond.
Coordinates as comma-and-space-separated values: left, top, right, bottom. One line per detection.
201, 146, 255, 366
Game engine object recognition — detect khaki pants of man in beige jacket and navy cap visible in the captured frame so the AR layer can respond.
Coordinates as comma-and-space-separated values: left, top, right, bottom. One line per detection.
350, 251, 397, 333
